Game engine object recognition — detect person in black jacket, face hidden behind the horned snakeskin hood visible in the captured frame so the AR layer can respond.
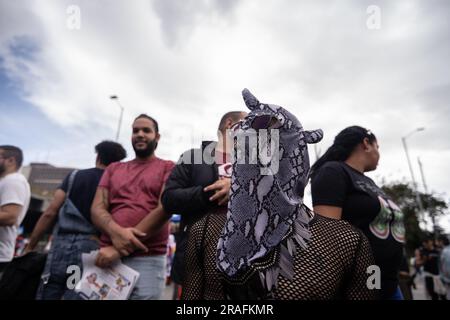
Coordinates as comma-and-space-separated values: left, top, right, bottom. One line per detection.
161, 111, 247, 285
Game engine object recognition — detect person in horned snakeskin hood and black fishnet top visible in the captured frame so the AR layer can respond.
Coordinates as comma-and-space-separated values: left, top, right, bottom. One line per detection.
182, 89, 374, 300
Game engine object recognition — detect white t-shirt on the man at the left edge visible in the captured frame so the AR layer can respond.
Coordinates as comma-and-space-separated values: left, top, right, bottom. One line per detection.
0, 172, 30, 262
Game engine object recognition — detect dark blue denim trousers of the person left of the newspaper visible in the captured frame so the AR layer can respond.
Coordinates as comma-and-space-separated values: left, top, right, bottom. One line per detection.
36, 234, 99, 300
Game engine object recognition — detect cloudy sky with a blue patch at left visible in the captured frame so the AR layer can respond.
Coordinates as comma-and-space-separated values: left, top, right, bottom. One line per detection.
0, 0, 450, 230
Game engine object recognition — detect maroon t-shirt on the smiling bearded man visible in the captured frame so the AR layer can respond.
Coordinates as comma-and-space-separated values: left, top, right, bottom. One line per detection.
98, 157, 174, 256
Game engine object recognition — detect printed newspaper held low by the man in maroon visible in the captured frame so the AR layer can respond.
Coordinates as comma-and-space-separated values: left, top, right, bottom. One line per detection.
75, 250, 139, 300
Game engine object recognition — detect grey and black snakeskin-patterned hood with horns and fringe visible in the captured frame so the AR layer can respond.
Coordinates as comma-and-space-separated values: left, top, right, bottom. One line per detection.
217, 89, 323, 291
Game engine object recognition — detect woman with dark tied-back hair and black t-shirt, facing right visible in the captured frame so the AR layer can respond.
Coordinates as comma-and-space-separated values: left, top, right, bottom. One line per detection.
311, 126, 405, 300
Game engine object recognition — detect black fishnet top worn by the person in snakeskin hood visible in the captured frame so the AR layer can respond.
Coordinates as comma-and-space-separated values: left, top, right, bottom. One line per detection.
182, 214, 376, 300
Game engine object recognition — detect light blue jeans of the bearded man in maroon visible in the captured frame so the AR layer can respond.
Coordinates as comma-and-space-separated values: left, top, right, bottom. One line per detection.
122, 255, 166, 300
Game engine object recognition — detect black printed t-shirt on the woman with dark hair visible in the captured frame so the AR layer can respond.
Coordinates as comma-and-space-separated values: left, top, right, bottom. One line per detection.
311, 161, 405, 297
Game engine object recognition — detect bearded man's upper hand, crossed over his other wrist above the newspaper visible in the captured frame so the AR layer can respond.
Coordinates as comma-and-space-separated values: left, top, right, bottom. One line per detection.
110, 227, 148, 256
